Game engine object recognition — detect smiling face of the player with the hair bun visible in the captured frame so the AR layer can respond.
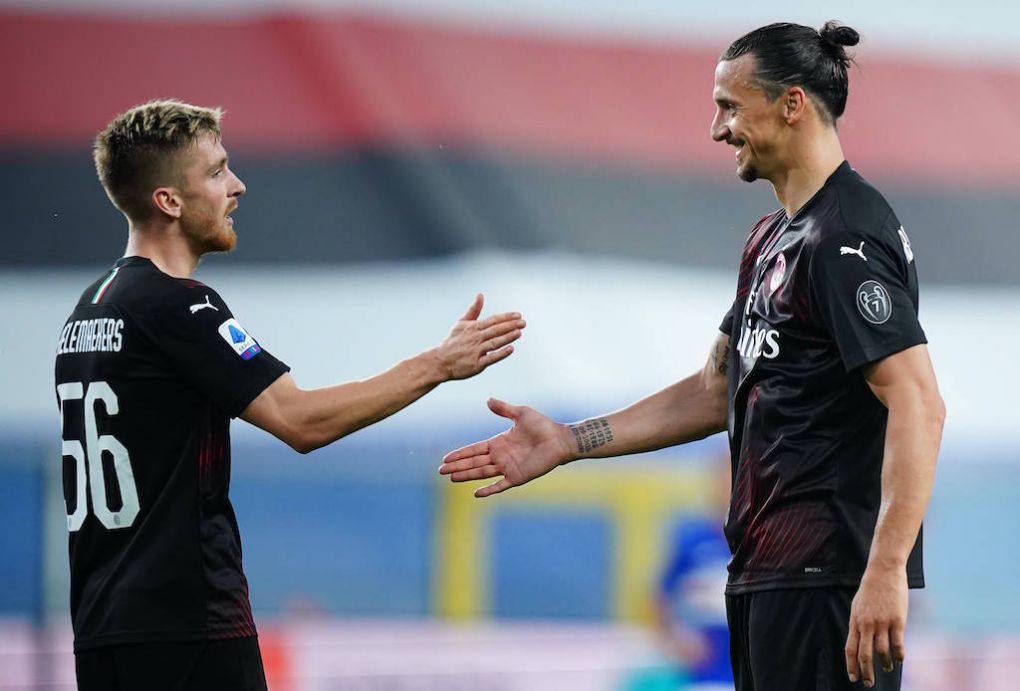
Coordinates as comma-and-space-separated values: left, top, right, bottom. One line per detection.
712, 54, 788, 183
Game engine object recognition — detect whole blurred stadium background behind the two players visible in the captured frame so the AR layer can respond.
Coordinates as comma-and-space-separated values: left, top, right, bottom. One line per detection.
0, 0, 1020, 691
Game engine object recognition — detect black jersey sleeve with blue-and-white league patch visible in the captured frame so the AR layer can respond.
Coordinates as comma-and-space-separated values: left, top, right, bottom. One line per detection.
143, 284, 290, 417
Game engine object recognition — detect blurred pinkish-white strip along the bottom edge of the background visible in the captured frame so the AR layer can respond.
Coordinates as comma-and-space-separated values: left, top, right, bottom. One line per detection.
0, 618, 1020, 691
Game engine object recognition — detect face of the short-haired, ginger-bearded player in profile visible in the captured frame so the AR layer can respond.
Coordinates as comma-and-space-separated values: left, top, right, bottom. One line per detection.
176, 133, 245, 256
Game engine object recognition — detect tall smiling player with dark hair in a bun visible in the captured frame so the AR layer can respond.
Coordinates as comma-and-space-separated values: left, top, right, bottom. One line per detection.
440, 21, 946, 691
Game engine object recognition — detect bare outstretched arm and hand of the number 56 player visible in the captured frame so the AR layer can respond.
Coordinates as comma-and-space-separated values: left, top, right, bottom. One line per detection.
241, 295, 525, 453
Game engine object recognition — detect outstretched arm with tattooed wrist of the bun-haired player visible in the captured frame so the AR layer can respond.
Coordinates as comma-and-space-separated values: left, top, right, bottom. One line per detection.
440, 334, 729, 497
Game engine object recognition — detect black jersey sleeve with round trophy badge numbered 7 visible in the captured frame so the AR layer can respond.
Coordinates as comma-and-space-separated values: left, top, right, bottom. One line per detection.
809, 217, 927, 372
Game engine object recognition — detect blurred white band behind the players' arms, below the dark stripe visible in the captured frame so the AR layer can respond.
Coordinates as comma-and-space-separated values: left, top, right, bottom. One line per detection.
0, 252, 1020, 447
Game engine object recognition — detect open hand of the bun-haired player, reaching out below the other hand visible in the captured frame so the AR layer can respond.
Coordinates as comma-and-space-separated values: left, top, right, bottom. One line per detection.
440, 398, 573, 497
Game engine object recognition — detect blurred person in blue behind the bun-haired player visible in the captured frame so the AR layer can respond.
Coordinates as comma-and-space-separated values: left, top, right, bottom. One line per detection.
653, 459, 733, 691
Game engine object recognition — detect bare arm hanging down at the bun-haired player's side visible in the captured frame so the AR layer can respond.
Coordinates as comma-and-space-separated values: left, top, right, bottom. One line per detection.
847, 345, 946, 688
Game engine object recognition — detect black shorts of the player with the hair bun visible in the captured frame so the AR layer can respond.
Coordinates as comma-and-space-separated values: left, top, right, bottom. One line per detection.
726, 588, 903, 691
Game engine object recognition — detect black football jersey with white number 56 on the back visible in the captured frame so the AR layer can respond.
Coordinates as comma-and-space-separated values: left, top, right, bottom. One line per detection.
56, 257, 288, 650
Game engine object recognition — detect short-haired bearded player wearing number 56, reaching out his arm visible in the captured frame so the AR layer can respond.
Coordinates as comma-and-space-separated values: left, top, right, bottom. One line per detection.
55, 100, 525, 691
